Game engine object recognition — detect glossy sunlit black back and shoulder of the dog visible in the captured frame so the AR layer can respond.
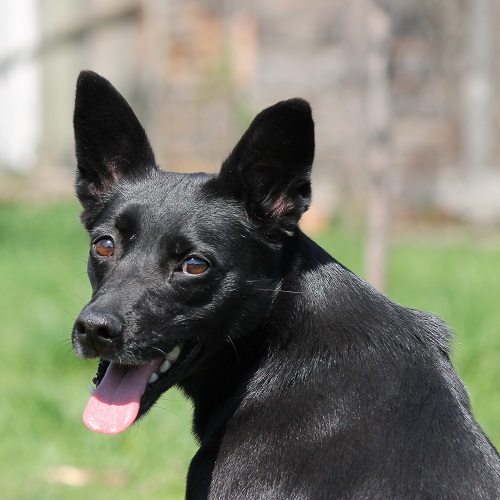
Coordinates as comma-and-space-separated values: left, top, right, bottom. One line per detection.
203, 235, 498, 498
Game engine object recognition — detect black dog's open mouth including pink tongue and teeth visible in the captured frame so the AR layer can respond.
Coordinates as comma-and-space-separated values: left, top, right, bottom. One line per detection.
83, 341, 200, 434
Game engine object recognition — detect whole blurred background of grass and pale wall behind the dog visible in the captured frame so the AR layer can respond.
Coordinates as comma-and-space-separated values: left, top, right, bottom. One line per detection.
0, 0, 500, 499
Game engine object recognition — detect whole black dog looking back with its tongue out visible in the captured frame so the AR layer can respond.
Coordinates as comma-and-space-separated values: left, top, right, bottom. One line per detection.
73, 72, 500, 500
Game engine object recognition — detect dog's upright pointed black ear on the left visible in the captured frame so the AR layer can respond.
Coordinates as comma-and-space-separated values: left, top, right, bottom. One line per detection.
73, 71, 155, 207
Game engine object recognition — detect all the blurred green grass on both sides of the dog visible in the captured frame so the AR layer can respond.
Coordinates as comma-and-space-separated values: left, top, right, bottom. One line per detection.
0, 204, 500, 500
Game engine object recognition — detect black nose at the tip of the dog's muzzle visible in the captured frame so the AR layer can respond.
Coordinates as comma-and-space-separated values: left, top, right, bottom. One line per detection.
73, 307, 124, 355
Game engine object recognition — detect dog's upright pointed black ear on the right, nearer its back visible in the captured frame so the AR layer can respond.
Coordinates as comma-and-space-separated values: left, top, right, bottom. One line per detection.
218, 99, 314, 233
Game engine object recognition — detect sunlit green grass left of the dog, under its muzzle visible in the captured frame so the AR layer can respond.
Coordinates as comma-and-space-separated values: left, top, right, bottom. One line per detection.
0, 205, 195, 500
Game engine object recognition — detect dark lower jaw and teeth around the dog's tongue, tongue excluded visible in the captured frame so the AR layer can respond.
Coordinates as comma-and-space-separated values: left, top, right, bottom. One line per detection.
92, 340, 202, 421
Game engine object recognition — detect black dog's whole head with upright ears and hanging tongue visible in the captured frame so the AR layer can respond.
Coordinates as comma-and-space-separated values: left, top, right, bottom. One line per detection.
72, 71, 314, 433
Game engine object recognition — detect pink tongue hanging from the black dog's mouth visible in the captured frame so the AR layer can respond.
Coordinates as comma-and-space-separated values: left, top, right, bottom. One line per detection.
83, 360, 161, 434
